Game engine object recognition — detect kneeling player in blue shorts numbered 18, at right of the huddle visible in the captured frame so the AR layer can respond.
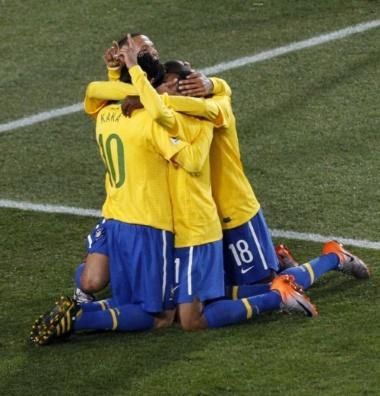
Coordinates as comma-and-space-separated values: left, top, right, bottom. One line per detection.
164, 71, 369, 298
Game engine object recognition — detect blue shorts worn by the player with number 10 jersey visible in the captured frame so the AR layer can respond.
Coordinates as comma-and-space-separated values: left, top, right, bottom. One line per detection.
104, 220, 174, 313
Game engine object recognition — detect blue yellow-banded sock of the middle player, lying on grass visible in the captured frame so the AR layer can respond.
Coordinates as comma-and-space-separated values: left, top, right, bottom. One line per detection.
204, 291, 281, 328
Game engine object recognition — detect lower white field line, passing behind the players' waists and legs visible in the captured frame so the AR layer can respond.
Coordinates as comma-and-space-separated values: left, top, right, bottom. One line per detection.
0, 199, 380, 250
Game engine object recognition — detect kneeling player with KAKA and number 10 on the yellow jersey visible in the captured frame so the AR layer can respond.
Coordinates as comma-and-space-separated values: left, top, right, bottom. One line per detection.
32, 44, 190, 345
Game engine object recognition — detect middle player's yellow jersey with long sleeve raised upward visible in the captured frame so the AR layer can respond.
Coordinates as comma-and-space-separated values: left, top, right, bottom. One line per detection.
129, 66, 222, 247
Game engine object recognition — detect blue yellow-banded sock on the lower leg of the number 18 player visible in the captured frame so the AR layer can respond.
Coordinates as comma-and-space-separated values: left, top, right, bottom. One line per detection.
281, 253, 339, 289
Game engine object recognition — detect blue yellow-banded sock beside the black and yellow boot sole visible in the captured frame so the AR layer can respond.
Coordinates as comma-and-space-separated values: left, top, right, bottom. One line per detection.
74, 304, 154, 331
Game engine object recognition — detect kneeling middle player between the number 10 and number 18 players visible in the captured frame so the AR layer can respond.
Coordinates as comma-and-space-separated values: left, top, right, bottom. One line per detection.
118, 36, 317, 330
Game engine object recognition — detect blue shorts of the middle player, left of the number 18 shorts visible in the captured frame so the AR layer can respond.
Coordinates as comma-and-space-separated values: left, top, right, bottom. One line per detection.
172, 240, 224, 304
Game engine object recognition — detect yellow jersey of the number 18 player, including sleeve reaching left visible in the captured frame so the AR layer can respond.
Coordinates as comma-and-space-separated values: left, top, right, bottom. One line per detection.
166, 78, 260, 229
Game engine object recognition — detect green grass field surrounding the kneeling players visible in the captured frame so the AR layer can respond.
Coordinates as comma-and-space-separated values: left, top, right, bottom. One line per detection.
0, 0, 380, 395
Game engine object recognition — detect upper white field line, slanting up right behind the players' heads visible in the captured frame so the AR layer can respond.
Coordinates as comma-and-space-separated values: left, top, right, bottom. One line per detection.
0, 19, 380, 133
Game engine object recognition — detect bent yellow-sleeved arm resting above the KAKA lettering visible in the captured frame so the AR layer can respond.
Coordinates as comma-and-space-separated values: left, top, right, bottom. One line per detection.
84, 81, 136, 116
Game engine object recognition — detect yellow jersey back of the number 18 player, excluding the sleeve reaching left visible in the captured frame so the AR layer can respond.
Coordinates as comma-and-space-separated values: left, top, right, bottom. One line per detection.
209, 95, 260, 229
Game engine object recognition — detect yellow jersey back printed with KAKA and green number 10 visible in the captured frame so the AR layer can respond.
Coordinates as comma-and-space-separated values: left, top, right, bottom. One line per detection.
96, 104, 177, 231
